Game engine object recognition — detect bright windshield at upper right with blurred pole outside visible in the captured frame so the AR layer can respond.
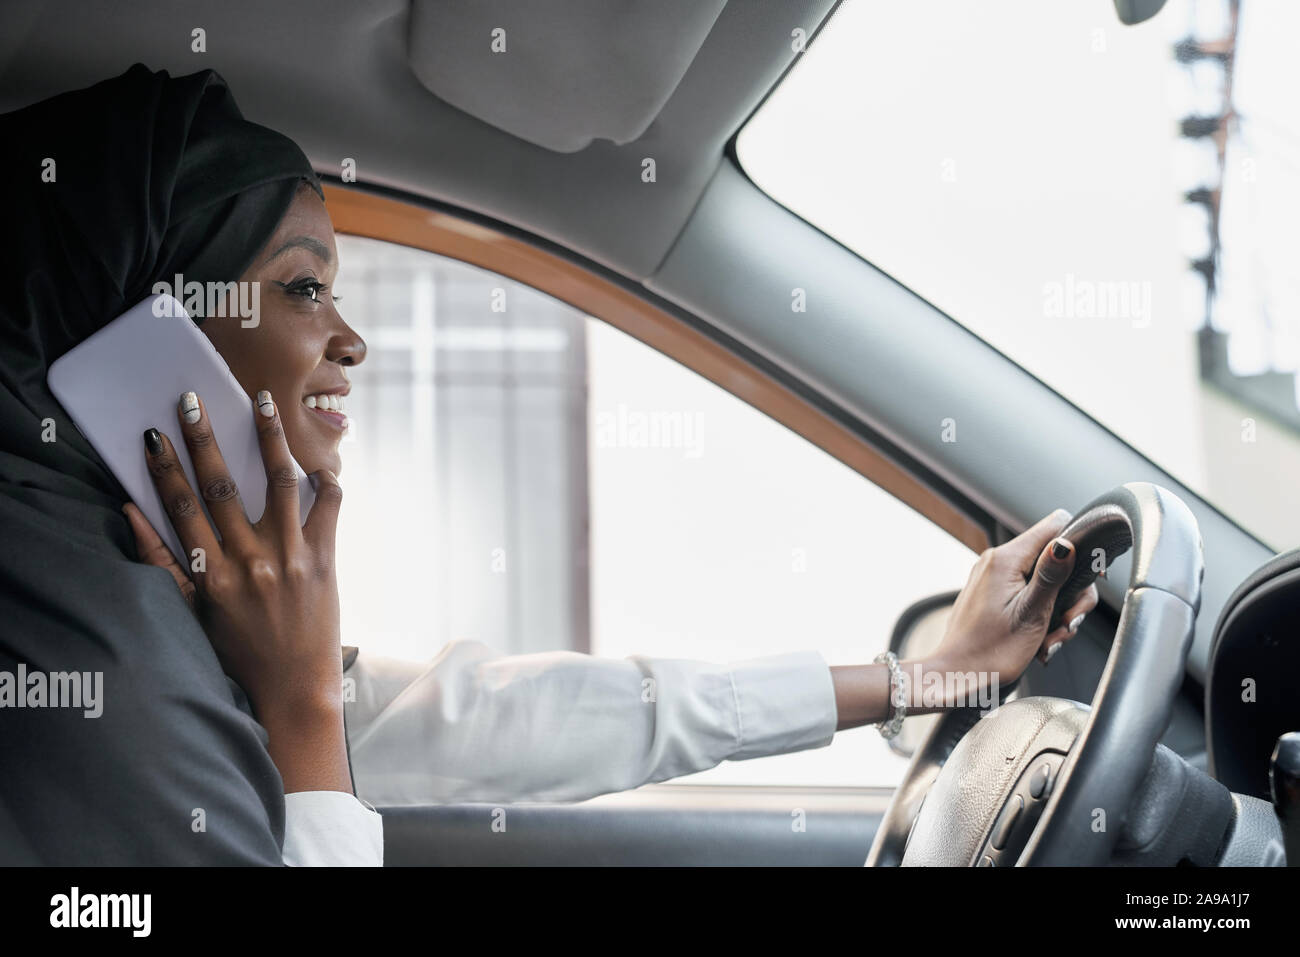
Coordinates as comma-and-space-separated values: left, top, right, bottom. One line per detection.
737, 0, 1300, 549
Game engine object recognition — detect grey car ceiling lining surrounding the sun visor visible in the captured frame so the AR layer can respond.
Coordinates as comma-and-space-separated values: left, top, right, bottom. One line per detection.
0, 0, 833, 280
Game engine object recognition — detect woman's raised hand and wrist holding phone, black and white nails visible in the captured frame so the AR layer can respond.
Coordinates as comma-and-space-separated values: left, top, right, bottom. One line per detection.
124, 393, 352, 793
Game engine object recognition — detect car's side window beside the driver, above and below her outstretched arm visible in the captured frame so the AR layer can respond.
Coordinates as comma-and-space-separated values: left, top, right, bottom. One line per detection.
335, 235, 974, 787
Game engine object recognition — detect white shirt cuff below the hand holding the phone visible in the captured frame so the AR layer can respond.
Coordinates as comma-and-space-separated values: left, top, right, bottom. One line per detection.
282, 791, 384, 867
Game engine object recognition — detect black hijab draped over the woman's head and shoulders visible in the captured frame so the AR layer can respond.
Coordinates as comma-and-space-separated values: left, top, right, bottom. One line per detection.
0, 64, 320, 863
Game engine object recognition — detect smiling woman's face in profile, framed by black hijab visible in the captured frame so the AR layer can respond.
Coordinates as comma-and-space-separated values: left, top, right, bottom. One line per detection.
199, 183, 365, 475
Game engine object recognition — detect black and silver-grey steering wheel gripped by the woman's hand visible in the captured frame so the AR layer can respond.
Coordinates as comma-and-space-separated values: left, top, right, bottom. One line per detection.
867, 482, 1205, 867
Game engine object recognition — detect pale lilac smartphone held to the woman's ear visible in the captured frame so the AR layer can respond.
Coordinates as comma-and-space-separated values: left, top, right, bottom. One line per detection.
48, 295, 316, 568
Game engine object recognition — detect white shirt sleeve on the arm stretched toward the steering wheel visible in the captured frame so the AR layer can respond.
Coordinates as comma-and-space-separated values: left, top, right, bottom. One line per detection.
345, 641, 839, 806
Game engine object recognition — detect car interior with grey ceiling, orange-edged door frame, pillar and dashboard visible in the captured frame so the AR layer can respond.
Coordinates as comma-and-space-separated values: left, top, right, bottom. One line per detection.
0, 0, 1300, 866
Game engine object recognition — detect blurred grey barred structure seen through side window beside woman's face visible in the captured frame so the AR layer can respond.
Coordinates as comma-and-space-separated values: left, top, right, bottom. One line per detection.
334, 235, 590, 661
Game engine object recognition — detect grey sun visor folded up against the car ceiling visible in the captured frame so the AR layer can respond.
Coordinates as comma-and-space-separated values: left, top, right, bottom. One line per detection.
407, 0, 727, 153
